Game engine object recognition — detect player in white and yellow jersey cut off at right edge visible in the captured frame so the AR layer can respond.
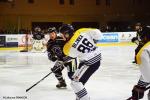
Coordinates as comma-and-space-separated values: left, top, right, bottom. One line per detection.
127, 27, 150, 100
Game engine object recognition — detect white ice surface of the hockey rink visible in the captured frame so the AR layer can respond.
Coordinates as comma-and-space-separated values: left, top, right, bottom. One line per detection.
0, 45, 147, 100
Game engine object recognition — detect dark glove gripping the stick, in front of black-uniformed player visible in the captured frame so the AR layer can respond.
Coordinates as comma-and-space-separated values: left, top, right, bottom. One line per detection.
51, 61, 64, 73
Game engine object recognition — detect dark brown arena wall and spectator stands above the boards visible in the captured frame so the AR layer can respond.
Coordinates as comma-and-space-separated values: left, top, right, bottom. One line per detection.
0, 0, 150, 34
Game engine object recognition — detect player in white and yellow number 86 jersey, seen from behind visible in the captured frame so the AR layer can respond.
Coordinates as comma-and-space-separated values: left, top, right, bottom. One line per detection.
59, 24, 101, 100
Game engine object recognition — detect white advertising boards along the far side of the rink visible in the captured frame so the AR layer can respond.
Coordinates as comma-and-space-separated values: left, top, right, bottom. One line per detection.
0, 32, 136, 47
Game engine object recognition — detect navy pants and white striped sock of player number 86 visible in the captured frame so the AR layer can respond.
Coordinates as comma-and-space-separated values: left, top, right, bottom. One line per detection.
71, 61, 100, 100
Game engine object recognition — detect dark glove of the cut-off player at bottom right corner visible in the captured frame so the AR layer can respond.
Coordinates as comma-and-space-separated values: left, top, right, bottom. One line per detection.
132, 85, 146, 100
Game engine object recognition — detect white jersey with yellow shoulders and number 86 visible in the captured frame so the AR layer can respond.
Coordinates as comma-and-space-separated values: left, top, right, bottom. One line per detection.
63, 28, 102, 63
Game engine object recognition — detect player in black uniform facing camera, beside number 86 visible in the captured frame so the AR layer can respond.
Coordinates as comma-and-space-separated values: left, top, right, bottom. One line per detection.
47, 27, 78, 88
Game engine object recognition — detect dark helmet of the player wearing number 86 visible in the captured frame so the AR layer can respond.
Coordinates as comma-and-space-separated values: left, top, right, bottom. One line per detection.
59, 24, 74, 36
